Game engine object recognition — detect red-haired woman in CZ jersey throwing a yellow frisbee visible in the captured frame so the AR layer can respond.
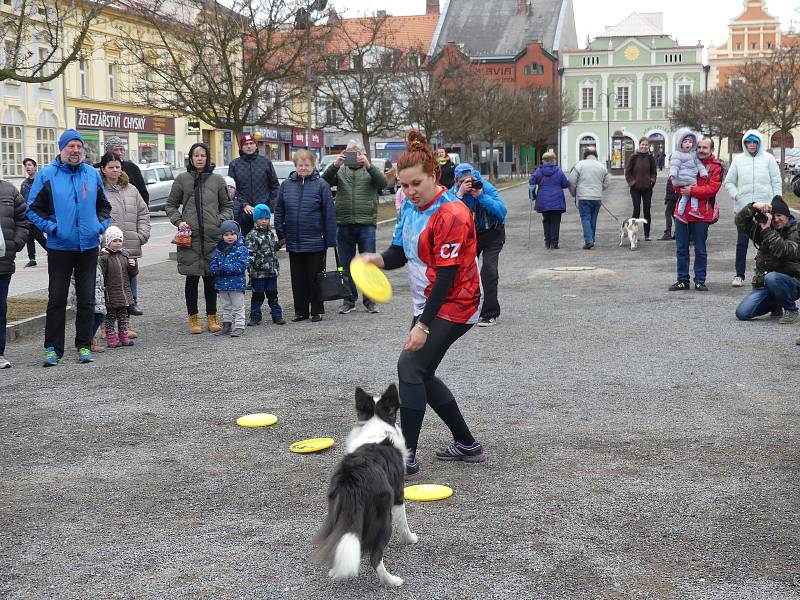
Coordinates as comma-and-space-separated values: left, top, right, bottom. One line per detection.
360, 131, 486, 475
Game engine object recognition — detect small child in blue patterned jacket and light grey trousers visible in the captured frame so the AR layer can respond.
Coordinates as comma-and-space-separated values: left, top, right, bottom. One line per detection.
208, 220, 249, 337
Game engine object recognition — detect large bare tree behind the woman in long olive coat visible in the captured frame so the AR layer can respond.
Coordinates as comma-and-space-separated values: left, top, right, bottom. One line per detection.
123, 0, 306, 145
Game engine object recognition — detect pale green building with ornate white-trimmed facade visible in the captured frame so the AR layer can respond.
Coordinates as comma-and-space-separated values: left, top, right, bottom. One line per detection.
559, 12, 708, 173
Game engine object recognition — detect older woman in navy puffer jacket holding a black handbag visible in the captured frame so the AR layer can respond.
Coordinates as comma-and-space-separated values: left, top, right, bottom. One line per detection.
275, 150, 336, 322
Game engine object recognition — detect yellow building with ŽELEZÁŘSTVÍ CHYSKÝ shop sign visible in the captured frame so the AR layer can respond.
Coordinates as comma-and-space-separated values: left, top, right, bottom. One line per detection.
0, 4, 225, 180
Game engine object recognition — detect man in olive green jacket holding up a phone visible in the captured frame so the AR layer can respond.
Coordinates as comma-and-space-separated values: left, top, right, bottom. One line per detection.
322, 141, 388, 315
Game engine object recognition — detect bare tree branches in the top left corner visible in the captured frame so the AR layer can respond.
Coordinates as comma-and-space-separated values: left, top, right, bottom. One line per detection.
0, 0, 114, 83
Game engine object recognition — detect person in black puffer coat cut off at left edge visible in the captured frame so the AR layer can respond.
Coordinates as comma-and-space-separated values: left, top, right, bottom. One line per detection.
0, 180, 29, 369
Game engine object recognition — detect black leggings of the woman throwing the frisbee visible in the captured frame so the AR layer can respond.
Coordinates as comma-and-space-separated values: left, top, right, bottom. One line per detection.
397, 317, 475, 456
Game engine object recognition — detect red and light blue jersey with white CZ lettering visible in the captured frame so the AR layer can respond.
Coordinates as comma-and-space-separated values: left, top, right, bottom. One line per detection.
392, 188, 483, 323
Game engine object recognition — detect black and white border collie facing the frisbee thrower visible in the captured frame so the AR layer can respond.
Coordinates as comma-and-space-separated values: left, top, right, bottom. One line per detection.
314, 384, 417, 587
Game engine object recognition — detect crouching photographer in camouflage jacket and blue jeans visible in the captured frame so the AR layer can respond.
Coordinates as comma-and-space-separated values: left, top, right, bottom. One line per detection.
736, 196, 800, 324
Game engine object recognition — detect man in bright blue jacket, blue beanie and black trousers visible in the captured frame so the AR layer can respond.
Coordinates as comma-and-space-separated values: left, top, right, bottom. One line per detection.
26, 129, 111, 367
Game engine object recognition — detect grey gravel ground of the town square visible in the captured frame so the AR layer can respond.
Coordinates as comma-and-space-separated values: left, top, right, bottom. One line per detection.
0, 180, 800, 600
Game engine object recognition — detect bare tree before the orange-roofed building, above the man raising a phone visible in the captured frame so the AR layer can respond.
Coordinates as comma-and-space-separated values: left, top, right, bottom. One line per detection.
315, 15, 407, 153
